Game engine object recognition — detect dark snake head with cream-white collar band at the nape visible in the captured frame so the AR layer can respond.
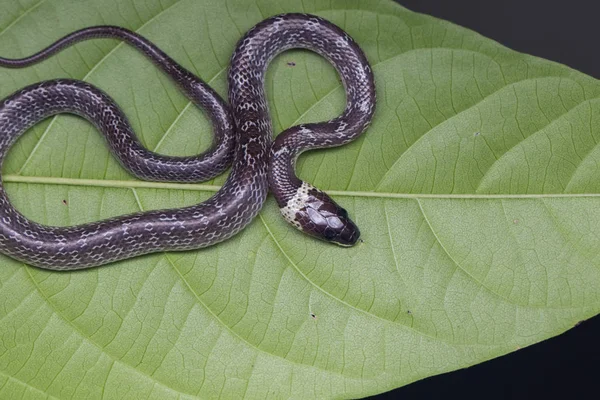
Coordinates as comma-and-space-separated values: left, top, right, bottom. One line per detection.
281, 182, 360, 247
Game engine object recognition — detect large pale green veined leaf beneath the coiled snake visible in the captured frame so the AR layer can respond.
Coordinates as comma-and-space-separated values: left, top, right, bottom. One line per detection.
0, 0, 600, 399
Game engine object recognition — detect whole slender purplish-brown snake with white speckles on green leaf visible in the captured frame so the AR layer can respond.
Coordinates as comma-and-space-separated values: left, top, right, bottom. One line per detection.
0, 13, 376, 271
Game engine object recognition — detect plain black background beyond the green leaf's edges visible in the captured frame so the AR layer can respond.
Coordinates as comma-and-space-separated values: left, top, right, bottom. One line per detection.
373, 0, 600, 400
